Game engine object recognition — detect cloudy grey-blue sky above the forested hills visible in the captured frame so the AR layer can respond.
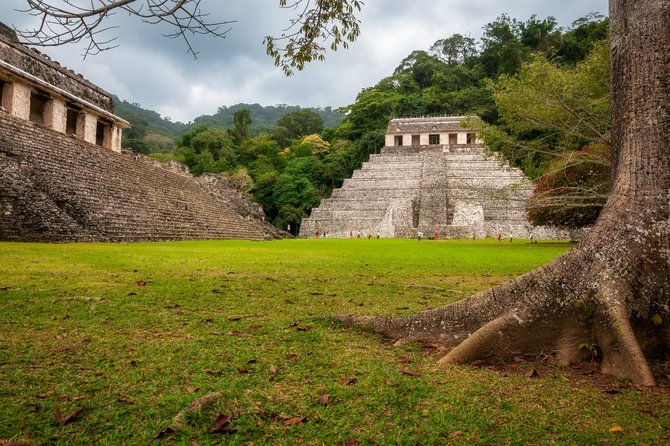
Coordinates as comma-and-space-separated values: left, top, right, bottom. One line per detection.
0, 0, 608, 122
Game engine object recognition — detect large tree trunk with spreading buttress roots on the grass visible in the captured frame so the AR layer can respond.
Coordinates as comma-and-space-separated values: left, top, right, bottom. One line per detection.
339, 0, 670, 385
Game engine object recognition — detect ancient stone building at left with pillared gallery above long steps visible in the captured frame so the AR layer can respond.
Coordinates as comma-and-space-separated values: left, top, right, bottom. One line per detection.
0, 25, 281, 241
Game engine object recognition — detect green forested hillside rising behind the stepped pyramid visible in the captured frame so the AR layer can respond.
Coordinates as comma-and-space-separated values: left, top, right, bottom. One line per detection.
117, 15, 609, 233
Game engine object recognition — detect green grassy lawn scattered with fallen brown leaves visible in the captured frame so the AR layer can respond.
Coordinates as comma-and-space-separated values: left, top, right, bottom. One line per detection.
0, 239, 670, 445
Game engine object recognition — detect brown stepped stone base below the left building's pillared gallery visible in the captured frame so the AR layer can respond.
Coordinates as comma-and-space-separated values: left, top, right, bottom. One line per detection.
0, 111, 282, 242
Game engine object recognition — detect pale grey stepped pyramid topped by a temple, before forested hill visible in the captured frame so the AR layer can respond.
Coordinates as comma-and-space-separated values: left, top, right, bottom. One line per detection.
300, 116, 569, 238
